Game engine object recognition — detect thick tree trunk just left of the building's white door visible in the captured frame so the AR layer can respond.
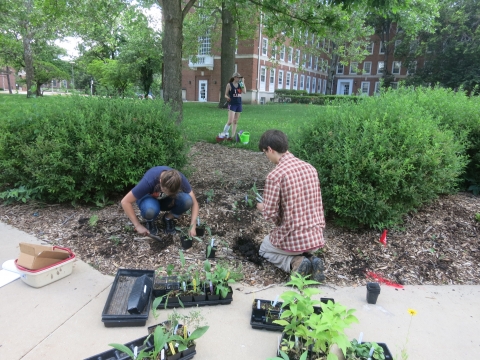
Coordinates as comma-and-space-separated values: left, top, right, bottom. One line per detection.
162, 0, 183, 124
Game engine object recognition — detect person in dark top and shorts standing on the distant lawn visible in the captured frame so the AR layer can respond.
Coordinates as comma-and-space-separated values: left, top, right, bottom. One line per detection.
223, 72, 247, 140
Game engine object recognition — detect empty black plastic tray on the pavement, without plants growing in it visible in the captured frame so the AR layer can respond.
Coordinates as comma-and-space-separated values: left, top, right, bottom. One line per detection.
102, 269, 154, 327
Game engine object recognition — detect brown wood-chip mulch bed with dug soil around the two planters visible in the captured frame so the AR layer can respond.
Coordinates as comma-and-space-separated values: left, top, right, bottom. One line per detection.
0, 143, 480, 286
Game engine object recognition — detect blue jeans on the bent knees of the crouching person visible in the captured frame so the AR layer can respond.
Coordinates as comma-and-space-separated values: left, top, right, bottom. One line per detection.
136, 192, 193, 221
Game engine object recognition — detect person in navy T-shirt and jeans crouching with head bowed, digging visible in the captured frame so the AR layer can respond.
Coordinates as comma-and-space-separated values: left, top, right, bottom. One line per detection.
122, 166, 199, 236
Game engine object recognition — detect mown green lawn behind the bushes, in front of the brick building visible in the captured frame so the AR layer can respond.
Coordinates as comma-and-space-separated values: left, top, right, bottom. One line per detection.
0, 94, 322, 151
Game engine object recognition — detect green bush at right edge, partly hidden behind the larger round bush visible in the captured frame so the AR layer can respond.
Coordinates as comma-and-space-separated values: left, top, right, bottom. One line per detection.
417, 87, 480, 194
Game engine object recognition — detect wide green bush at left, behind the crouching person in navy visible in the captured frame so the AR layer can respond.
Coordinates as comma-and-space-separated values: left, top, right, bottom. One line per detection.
0, 96, 186, 202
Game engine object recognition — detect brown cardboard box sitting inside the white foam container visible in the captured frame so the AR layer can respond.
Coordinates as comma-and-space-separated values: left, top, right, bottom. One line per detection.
16, 243, 72, 270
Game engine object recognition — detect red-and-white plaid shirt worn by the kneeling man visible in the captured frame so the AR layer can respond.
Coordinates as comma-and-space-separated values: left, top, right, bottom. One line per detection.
263, 151, 325, 252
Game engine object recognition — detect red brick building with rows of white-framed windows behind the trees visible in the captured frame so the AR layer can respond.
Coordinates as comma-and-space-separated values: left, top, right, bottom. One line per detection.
182, 26, 412, 104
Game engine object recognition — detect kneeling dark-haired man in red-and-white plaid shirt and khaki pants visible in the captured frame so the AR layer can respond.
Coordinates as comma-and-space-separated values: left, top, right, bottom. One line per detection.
257, 130, 325, 281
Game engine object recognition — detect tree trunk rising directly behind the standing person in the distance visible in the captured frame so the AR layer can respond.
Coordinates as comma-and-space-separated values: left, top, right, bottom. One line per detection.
218, 1, 237, 108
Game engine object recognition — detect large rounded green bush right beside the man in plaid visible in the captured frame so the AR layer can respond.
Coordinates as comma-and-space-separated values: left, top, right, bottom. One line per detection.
292, 89, 466, 229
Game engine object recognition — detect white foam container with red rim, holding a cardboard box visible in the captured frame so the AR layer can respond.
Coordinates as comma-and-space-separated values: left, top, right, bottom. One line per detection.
15, 252, 75, 288
